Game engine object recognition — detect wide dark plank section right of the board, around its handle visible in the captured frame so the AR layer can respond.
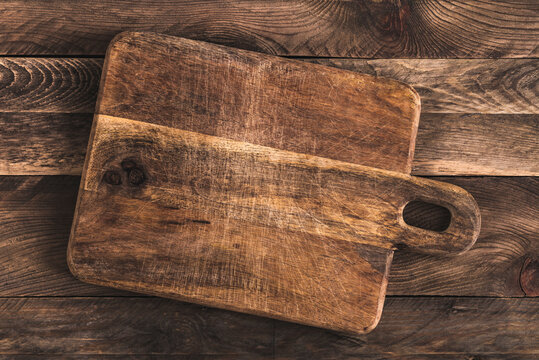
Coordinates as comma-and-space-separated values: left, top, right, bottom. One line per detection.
388, 177, 539, 296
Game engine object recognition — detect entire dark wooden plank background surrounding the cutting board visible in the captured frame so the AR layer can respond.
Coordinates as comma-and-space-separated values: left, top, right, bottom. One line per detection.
0, 0, 539, 359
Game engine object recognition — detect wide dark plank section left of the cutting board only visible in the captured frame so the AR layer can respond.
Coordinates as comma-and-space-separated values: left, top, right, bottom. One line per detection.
0, 176, 128, 296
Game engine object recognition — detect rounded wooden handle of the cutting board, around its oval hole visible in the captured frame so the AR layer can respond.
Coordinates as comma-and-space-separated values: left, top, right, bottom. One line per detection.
395, 177, 481, 254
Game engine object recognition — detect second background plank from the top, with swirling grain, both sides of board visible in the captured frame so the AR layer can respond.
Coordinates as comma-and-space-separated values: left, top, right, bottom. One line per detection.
0, 57, 539, 114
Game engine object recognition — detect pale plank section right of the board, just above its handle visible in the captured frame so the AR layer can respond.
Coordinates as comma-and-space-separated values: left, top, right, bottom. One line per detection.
412, 114, 539, 176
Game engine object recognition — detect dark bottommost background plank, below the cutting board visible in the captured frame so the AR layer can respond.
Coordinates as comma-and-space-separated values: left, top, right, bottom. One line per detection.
0, 297, 539, 359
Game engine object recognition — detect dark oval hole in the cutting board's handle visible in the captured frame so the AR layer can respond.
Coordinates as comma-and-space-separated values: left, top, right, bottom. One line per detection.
402, 200, 451, 232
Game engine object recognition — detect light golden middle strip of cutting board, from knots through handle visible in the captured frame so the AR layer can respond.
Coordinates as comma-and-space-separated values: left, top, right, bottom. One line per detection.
74, 115, 480, 253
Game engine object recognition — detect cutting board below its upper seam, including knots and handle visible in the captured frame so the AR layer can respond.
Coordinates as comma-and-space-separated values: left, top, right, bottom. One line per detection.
68, 115, 480, 333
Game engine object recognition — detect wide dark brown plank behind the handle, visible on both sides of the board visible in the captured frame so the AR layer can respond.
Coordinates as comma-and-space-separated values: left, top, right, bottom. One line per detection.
0, 176, 539, 297
